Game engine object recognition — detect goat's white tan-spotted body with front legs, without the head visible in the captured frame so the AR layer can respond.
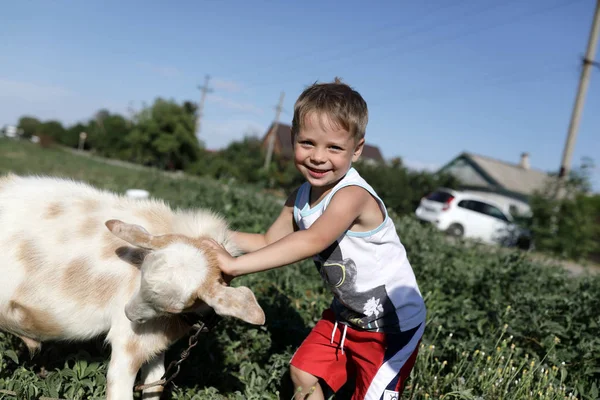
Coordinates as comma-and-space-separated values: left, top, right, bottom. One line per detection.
0, 175, 255, 399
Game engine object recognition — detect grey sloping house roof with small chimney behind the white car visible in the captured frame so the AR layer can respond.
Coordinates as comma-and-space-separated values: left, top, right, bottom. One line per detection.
462, 153, 549, 195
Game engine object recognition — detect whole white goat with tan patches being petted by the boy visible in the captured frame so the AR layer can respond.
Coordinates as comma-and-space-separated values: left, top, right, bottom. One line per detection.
0, 174, 265, 400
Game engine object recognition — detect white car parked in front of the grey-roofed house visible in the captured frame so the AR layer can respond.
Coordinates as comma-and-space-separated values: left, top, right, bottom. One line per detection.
415, 189, 529, 247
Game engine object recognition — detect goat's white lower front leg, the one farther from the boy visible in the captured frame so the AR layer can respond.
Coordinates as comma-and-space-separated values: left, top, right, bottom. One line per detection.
106, 340, 142, 400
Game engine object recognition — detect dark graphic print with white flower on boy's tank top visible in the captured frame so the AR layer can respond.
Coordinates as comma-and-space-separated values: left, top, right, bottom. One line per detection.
315, 241, 398, 331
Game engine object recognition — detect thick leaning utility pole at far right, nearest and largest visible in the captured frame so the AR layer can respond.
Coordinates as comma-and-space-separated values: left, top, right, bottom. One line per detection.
558, 0, 600, 180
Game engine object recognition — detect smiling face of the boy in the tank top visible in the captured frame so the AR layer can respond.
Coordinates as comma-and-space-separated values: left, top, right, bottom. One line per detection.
294, 112, 364, 189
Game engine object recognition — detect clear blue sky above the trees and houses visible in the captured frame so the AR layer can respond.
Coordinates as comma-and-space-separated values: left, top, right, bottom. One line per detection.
0, 0, 600, 190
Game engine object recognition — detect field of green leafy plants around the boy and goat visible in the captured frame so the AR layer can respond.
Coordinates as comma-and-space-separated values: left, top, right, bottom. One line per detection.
0, 139, 600, 400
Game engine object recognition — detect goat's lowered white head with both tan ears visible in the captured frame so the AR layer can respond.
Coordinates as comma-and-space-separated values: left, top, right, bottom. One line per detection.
106, 220, 265, 325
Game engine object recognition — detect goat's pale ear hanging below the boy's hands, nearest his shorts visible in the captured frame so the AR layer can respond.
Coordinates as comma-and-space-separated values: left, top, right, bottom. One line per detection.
198, 284, 265, 325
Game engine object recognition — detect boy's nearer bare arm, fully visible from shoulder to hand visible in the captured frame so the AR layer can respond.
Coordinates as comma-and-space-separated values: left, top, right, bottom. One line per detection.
212, 186, 370, 276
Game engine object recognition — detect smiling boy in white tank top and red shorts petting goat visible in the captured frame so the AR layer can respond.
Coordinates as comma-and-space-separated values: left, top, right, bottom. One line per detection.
205, 78, 426, 400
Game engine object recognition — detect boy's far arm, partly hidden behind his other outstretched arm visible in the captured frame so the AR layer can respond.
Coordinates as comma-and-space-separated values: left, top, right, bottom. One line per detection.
231, 189, 298, 253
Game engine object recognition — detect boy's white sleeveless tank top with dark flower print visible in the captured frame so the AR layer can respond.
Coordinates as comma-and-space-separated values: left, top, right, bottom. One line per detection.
294, 168, 426, 332
